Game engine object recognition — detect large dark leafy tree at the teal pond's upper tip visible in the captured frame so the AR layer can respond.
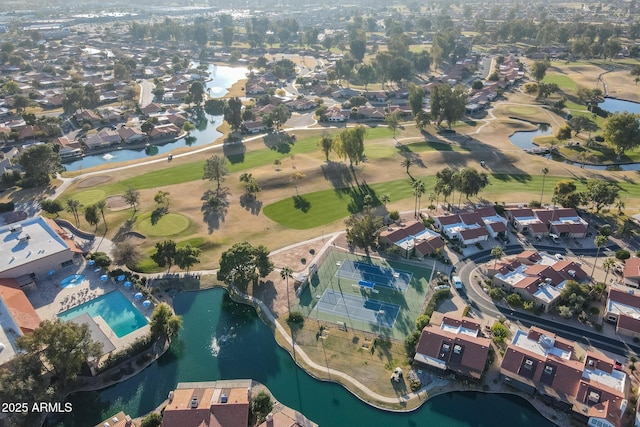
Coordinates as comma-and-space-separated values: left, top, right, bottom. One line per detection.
217, 242, 273, 287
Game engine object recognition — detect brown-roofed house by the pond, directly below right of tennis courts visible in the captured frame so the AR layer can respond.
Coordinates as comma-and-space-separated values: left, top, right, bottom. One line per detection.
413, 315, 491, 380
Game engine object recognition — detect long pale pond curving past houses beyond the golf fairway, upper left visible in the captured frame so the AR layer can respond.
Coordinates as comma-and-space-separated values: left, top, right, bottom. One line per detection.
63, 65, 247, 171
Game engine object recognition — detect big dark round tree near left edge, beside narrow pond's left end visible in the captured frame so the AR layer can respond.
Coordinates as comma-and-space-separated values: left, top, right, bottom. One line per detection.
18, 144, 61, 187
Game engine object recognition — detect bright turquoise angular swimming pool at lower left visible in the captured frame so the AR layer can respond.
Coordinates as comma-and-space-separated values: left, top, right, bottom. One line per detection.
58, 291, 148, 338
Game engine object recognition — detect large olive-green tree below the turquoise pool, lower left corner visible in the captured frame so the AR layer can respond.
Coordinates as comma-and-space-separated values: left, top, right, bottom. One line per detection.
16, 319, 102, 391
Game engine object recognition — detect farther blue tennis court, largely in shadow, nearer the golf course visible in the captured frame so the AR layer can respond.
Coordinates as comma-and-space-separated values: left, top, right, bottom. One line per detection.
336, 259, 413, 292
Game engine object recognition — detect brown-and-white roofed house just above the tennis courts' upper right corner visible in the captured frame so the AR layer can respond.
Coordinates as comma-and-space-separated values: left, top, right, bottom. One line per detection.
378, 221, 444, 259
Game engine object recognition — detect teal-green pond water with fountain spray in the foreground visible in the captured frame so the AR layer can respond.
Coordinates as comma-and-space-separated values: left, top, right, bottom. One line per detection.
48, 289, 553, 427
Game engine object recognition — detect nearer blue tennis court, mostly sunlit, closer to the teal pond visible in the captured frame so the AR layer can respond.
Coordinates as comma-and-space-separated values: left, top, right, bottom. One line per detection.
317, 289, 400, 329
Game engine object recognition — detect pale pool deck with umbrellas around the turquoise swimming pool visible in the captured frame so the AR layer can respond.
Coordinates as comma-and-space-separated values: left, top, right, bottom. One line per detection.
27, 265, 153, 351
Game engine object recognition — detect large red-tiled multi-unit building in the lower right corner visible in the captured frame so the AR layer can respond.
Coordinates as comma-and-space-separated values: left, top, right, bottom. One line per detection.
500, 327, 629, 427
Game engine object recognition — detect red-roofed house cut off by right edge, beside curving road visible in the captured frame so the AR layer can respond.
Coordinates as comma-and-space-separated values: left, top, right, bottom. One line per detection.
604, 286, 640, 338
